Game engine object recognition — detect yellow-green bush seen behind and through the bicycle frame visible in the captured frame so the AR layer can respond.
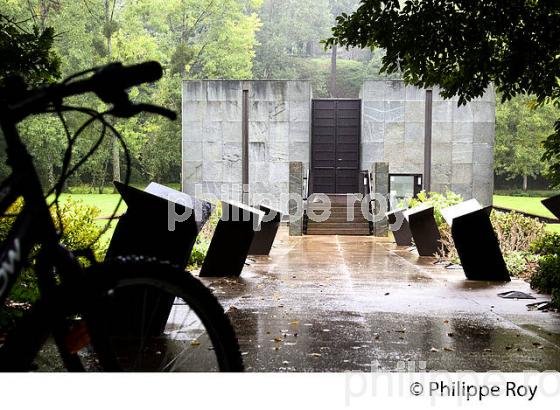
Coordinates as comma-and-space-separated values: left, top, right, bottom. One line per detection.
0, 198, 106, 328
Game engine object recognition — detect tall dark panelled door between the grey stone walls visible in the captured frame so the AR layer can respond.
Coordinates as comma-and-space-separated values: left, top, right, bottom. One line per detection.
311, 100, 361, 194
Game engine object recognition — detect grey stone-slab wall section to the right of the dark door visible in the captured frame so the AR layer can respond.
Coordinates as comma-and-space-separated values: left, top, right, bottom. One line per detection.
360, 80, 496, 205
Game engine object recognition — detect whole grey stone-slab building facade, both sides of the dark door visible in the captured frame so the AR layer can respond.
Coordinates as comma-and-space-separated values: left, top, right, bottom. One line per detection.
182, 80, 495, 213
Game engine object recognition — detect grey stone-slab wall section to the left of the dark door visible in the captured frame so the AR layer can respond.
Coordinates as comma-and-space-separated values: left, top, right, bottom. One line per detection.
182, 81, 311, 213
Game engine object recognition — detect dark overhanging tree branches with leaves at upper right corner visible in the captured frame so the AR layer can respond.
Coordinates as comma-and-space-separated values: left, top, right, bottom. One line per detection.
326, 0, 560, 184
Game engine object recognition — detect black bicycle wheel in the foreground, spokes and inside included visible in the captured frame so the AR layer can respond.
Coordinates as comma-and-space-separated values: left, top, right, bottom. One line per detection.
78, 257, 243, 372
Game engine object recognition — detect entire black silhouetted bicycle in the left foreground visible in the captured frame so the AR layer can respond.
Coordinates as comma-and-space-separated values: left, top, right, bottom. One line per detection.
0, 62, 243, 371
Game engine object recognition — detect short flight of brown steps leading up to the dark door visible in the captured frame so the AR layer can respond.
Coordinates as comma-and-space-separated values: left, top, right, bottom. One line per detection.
307, 194, 370, 235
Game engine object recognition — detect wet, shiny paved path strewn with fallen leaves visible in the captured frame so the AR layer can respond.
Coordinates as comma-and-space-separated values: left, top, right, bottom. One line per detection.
196, 227, 560, 372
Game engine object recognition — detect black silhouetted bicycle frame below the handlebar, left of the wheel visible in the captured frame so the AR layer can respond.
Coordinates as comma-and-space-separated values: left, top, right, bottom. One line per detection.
0, 103, 94, 370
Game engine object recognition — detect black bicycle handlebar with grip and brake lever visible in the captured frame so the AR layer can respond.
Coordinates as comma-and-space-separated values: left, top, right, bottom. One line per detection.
4, 61, 176, 122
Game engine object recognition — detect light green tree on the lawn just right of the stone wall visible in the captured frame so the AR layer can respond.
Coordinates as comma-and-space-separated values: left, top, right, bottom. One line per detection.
494, 96, 556, 191
